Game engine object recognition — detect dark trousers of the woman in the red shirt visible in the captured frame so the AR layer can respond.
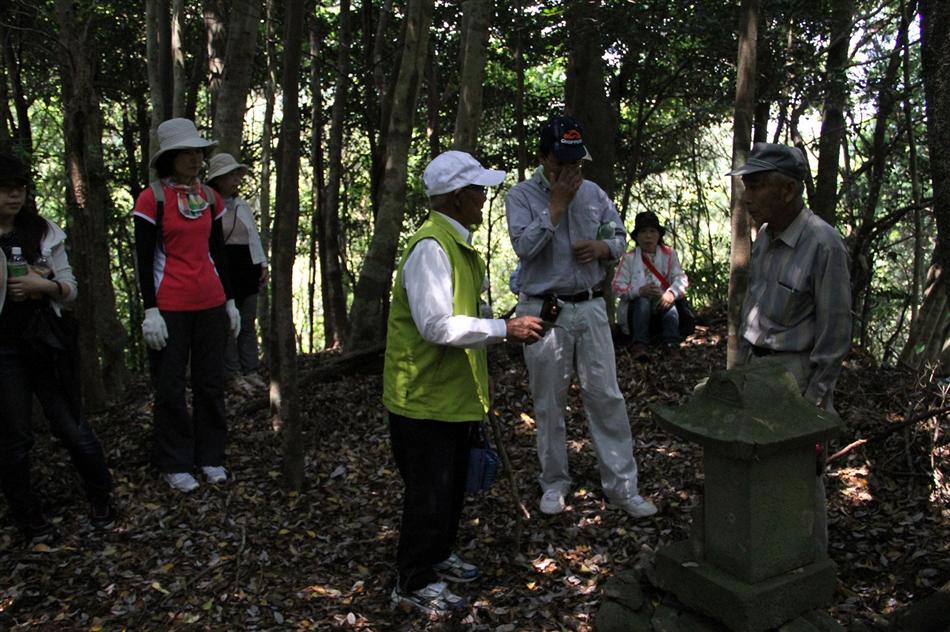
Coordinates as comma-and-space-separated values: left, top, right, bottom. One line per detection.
148, 305, 228, 474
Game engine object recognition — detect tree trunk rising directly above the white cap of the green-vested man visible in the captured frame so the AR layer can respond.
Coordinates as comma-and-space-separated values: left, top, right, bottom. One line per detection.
452, 0, 494, 153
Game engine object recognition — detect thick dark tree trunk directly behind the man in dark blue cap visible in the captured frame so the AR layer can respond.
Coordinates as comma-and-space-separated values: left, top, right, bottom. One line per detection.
564, 0, 617, 197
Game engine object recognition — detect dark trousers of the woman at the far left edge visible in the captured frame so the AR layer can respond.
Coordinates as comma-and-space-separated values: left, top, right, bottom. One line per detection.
0, 345, 112, 524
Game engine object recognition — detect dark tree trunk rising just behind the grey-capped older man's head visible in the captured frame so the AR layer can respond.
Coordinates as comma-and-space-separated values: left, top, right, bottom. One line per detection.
808, 0, 854, 226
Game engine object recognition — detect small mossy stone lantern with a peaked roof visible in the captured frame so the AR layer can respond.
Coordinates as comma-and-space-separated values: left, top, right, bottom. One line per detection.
653, 363, 842, 632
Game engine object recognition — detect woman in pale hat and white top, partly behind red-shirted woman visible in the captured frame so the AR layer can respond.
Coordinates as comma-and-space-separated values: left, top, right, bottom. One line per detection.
207, 153, 267, 389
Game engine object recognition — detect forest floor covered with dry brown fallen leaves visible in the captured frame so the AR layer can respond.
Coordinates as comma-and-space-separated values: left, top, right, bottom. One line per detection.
0, 318, 950, 632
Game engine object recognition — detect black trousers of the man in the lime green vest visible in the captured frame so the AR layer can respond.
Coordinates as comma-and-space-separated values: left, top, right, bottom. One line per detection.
389, 413, 476, 591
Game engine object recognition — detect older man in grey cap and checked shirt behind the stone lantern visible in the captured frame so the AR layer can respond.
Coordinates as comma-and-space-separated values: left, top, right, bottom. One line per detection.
729, 143, 851, 551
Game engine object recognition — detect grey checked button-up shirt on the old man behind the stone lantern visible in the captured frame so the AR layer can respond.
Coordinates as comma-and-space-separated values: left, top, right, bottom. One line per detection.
740, 208, 851, 403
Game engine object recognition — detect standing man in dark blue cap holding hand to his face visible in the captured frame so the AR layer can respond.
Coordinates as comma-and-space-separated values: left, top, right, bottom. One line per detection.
505, 116, 656, 518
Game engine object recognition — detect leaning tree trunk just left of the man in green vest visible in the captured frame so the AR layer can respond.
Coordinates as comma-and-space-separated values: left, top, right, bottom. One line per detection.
347, 0, 433, 350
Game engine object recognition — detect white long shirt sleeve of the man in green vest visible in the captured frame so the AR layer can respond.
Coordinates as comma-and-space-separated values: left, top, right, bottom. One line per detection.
402, 239, 507, 348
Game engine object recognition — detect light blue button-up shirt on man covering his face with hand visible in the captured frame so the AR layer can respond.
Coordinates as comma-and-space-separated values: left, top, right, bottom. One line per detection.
505, 169, 627, 296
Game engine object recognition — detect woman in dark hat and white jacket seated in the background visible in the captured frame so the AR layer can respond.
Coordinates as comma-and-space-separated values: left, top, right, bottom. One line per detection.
613, 211, 689, 360
